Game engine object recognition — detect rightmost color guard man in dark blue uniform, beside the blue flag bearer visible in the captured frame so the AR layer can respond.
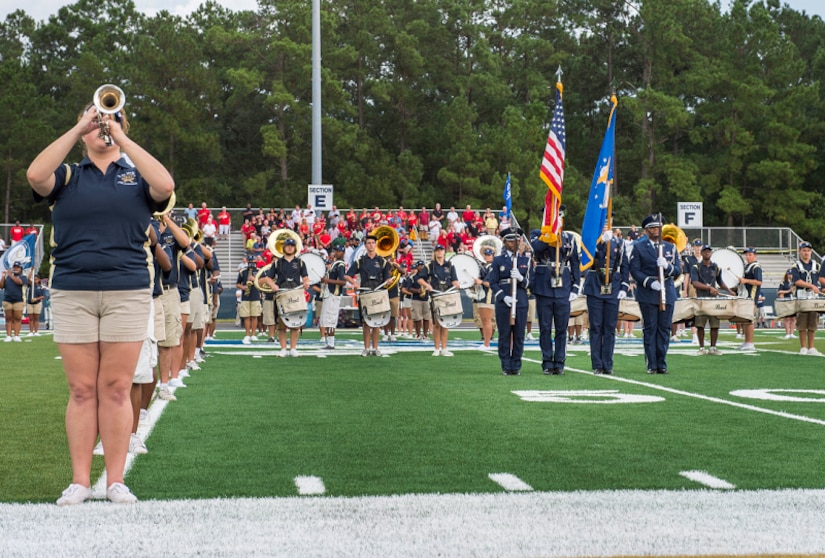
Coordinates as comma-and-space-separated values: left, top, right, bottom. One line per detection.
629, 215, 682, 374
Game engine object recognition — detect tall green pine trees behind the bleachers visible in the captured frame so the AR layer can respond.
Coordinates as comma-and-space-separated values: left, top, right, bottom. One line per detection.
0, 0, 825, 240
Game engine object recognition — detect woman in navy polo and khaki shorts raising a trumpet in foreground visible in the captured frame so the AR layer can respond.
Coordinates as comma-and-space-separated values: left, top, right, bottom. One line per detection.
26, 87, 175, 505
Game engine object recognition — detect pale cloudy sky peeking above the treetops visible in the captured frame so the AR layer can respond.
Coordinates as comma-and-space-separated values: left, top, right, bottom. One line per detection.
0, 0, 825, 26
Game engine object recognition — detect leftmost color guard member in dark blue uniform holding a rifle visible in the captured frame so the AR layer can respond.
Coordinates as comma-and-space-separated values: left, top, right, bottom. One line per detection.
487, 227, 533, 376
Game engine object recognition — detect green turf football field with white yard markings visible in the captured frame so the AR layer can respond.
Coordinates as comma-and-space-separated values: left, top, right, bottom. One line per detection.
0, 330, 825, 502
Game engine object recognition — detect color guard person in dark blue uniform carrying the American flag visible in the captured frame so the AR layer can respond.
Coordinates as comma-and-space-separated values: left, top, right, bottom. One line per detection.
532, 231, 582, 376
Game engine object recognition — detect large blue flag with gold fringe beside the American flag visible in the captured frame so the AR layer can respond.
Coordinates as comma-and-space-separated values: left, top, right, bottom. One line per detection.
580, 95, 619, 271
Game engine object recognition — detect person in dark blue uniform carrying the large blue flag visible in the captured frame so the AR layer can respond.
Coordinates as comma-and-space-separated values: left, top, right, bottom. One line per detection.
584, 230, 630, 374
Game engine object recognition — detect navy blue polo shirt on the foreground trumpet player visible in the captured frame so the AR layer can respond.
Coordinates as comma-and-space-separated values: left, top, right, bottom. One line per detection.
34, 157, 164, 291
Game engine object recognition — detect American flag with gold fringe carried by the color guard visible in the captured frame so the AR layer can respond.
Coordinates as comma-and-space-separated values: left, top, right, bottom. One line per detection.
539, 80, 567, 243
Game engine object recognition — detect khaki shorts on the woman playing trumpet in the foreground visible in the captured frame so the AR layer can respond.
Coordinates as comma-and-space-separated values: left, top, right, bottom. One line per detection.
52, 289, 152, 344
